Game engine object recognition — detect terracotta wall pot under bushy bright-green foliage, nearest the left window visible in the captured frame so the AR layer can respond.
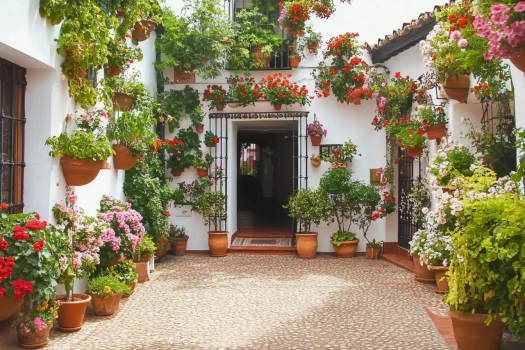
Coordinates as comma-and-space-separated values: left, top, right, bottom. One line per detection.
60, 156, 111, 186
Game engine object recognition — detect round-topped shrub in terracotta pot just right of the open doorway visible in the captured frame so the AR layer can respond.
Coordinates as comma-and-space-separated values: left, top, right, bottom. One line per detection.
283, 189, 327, 259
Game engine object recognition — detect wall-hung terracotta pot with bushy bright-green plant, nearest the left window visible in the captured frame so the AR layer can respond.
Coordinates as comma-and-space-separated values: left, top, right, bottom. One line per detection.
46, 129, 115, 186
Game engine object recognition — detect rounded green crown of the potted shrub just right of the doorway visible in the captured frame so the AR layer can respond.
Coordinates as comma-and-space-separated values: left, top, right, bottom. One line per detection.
283, 188, 328, 233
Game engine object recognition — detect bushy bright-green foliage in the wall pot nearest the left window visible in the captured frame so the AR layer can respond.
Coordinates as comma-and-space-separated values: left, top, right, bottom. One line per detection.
46, 129, 115, 161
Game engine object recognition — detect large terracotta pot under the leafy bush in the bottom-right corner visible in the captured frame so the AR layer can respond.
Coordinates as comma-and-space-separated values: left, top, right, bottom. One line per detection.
448, 310, 505, 350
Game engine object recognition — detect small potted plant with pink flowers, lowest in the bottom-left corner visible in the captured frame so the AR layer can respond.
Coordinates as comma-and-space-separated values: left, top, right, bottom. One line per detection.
13, 299, 61, 349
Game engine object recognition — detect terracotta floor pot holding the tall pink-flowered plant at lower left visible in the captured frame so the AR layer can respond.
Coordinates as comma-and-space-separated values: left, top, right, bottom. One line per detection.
57, 294, 91, 332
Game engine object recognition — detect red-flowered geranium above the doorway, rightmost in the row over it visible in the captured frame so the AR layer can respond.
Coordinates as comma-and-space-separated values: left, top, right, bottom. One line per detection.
261, 73, 310, 111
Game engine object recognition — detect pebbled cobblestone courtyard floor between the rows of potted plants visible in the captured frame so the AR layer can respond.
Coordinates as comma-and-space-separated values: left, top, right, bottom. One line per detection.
1, 255, 520, 350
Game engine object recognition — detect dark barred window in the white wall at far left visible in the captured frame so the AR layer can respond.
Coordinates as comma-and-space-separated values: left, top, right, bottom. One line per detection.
0, 58, 26, 214
